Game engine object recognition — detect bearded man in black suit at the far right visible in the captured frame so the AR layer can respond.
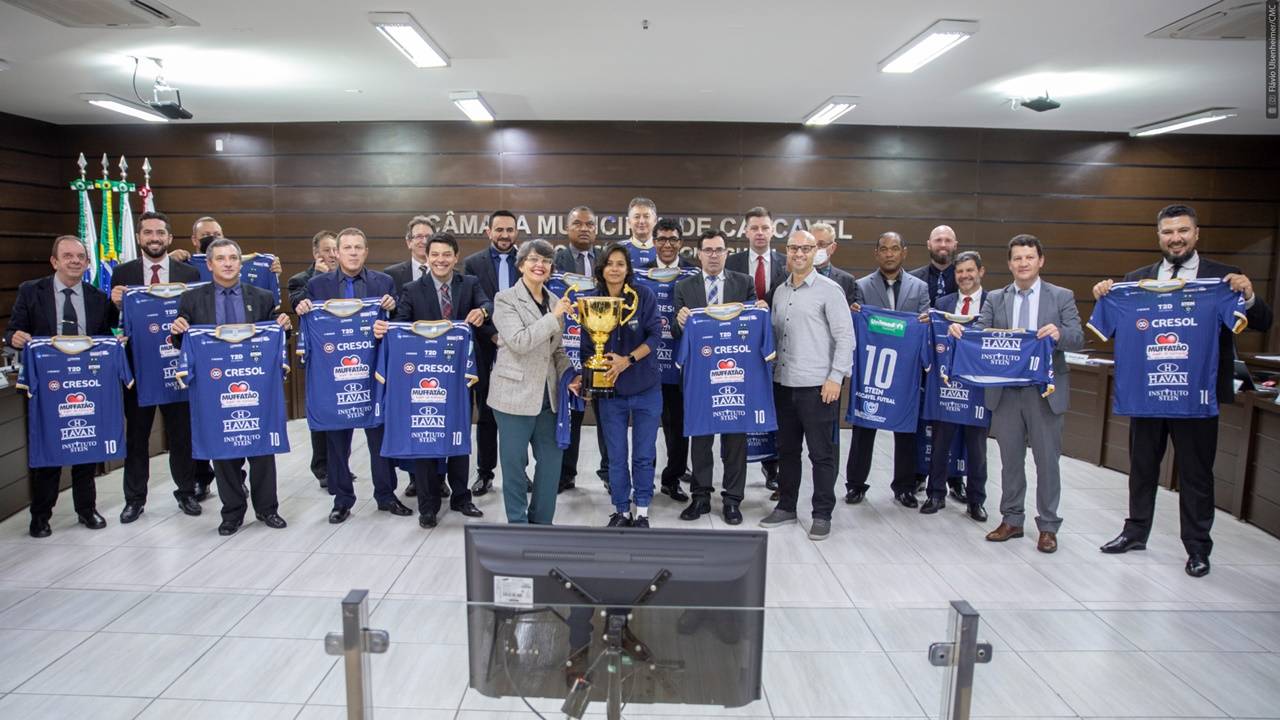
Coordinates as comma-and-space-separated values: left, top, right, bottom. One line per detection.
1095, 205, 1271, 578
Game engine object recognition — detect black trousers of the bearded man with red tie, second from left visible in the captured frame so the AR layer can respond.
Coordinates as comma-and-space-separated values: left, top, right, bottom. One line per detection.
124, 389, 196, 505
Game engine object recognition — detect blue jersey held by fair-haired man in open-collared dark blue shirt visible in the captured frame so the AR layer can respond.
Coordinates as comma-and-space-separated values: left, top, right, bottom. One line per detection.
298, 297, 387, 432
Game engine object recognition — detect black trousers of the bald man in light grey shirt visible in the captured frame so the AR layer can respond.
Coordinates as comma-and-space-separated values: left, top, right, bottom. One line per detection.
773, 383, 838, 520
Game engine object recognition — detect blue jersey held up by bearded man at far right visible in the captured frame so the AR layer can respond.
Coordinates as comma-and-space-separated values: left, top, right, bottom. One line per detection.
1088, 278, 1248, 418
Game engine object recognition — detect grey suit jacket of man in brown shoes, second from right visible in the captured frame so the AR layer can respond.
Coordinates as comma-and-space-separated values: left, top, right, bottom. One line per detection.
973, 279, 1084, 415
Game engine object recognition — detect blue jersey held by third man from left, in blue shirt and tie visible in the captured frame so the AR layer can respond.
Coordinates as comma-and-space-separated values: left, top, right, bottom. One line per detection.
178, 322, 289, 460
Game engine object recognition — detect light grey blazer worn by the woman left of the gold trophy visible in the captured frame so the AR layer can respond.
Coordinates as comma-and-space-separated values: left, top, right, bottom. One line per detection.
489, 281, 571, 415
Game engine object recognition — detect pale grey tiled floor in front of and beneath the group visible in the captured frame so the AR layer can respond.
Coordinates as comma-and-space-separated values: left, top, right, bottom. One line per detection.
0, 424, 1280, 720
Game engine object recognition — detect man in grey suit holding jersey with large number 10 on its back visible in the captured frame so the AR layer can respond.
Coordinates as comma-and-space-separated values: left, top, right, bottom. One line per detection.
845, 231, 929, 507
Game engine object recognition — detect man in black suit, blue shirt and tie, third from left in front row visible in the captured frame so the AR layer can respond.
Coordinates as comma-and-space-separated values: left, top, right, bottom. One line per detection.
169, 237, 289, 536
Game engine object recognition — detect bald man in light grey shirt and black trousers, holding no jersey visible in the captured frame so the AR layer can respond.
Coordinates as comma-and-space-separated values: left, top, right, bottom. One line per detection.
760, 231, 854, 541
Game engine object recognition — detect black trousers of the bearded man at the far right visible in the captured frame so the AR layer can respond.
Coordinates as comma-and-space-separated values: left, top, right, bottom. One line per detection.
1124, 418, 1217, 556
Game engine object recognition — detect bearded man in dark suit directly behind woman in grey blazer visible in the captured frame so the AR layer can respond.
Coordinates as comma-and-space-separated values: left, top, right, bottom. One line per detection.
462, 210, 518, 496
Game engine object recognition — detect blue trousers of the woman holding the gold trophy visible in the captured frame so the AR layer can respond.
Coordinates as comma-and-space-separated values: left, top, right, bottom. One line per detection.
598, 384, 662, 512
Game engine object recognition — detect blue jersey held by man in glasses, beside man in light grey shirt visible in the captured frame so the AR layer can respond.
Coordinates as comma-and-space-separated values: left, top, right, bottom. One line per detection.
676, 302, 778, 437
